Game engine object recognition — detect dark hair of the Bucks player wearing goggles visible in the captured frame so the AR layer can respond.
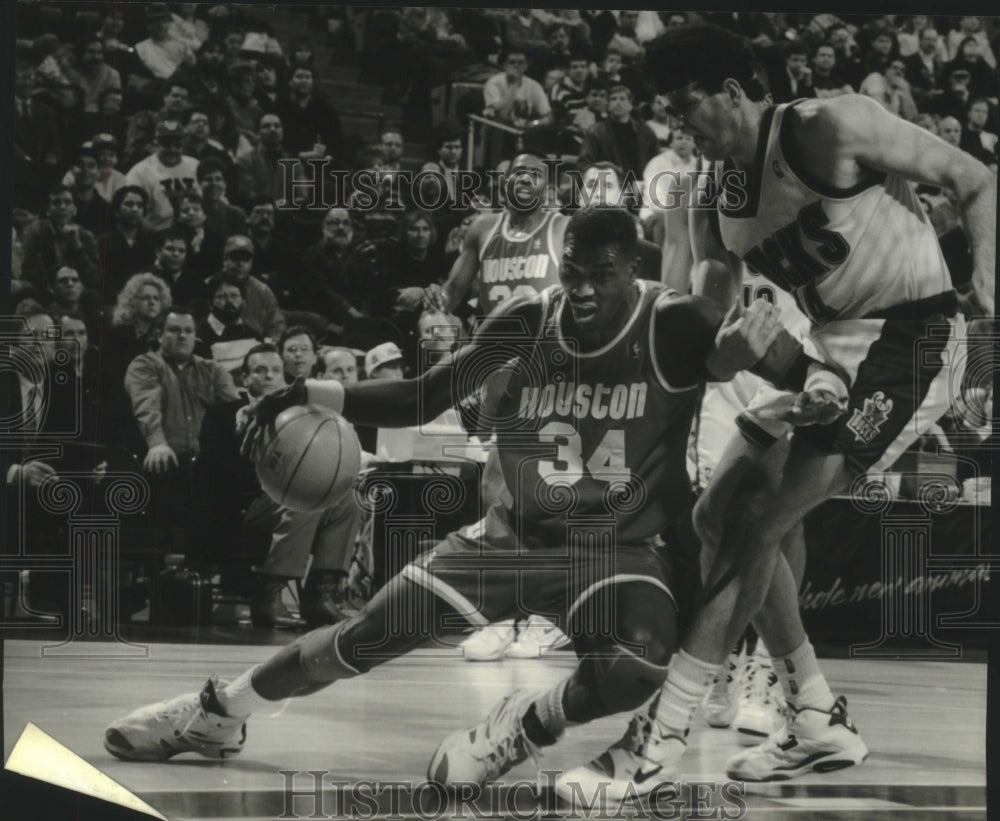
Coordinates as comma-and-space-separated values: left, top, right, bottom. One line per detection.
646, 23, 766, 102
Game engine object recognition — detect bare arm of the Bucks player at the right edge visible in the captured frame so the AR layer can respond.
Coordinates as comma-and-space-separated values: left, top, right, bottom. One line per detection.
792, 94, 997, 316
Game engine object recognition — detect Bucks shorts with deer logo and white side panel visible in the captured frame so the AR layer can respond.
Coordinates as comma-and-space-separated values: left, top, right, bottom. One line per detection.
795, 313, 966, 475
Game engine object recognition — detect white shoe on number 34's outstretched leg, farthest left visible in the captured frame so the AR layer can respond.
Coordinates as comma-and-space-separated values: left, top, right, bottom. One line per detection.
104, 676, 247, 761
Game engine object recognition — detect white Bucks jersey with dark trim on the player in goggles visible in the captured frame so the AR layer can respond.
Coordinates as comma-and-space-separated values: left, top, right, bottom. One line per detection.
716, 103, 952, 324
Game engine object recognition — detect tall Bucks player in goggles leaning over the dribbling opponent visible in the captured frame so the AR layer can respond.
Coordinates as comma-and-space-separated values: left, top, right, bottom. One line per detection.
563, 25, 996, 797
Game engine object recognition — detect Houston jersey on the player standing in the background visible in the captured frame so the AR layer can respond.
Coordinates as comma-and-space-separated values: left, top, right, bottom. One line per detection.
479, 211, 559, 314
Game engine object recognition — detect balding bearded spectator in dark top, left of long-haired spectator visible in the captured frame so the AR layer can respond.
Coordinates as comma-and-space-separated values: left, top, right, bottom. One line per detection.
295, 208, 376, 326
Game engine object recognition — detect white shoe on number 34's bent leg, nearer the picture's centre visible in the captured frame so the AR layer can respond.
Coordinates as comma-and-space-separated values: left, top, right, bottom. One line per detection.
427, 690, 539, 787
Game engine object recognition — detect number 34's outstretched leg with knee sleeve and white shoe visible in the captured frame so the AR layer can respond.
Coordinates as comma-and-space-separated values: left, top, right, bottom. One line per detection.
104, 576, 461, 761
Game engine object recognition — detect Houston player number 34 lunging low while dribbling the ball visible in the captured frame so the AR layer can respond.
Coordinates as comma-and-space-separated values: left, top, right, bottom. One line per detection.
105, 209, 846, 786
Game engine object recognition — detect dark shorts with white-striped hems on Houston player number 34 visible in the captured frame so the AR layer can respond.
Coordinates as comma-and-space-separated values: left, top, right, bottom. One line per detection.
400, 505, 676, 632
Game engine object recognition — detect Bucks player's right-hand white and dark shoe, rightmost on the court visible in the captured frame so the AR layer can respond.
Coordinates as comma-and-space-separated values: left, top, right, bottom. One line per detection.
726, 696, 868, 781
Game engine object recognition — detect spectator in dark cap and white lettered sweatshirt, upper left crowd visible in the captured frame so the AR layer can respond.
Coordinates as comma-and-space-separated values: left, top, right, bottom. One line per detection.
125, 120, 198, 231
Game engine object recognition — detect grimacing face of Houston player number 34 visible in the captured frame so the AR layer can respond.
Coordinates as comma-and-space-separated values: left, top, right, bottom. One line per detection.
559, 237, 638, 333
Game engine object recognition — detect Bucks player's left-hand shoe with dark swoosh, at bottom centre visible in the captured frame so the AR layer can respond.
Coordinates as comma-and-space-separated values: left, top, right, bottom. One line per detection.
555, 708, 687, 807
